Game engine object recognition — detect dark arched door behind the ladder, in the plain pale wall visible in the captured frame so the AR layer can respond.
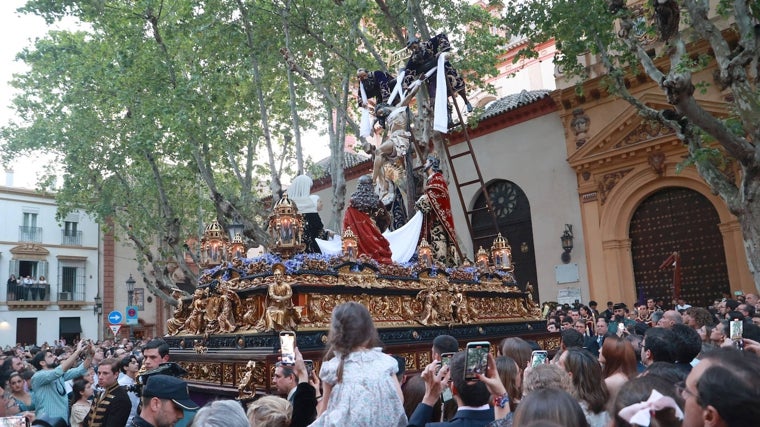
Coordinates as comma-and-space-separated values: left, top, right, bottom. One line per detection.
472, 180, 538, 298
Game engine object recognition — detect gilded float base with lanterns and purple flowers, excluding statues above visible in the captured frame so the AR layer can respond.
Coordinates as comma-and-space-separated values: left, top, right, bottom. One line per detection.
165, 195, 559, 399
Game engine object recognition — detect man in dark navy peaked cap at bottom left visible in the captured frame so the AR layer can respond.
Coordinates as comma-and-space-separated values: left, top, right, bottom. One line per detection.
129, 375, 198, 427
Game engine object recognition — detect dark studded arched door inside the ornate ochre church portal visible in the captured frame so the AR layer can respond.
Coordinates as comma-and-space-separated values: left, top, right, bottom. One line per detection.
629, 187, 730, 307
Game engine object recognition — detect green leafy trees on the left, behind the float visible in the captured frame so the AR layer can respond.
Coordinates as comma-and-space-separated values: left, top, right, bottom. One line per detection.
0, 0, 504, 296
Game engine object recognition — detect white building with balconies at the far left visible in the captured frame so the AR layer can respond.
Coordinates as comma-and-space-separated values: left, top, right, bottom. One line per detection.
0, 186, 102, 346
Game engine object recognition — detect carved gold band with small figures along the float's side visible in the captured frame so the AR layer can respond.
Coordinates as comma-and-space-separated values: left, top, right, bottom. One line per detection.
168, 254, 544, 338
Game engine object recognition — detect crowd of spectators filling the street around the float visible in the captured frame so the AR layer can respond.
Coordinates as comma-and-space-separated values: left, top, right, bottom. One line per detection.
0, 294, 760, 427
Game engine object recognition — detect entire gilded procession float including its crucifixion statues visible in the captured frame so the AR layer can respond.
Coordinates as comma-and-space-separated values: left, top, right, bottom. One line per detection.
165, 34, 559, 400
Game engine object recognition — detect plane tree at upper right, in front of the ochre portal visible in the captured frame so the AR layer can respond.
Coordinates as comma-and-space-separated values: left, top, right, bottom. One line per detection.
503, 0, 760, 290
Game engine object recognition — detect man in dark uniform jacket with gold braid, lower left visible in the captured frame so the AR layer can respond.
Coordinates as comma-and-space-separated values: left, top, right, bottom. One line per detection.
84, 358, 132, 427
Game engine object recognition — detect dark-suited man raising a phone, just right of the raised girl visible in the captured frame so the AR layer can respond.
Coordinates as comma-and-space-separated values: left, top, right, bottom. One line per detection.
407, 351, 496, 427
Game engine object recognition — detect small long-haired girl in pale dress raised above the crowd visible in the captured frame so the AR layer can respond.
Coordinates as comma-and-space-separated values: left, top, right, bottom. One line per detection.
312, 302, 407, 427
